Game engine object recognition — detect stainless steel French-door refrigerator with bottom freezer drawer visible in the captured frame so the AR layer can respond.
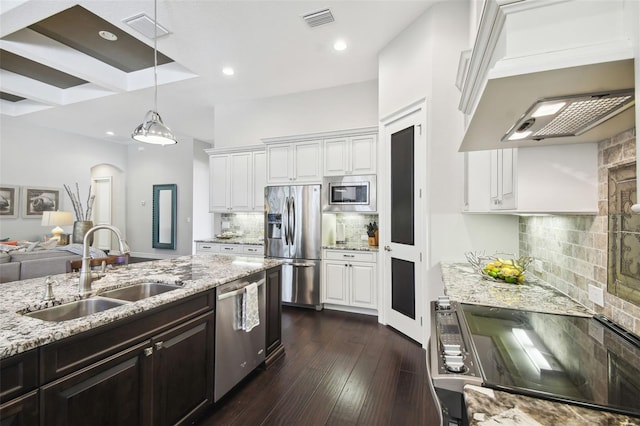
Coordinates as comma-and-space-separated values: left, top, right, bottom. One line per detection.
264, 185, 322, 310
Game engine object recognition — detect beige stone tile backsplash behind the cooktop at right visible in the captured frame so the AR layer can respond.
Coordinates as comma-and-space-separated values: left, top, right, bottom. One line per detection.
519, 129, 640, 335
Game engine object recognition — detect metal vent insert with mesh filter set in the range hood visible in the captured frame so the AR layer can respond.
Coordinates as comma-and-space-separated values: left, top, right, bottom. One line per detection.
502, 89, 635, 141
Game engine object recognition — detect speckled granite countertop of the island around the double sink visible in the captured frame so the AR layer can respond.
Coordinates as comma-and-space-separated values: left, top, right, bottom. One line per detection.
0, 254, 282, 359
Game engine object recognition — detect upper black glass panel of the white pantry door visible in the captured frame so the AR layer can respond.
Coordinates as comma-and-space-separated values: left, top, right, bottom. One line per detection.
391, 126, 415, 245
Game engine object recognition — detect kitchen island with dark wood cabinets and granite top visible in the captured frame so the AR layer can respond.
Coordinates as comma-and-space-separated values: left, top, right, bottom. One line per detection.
0, 255, 283, 425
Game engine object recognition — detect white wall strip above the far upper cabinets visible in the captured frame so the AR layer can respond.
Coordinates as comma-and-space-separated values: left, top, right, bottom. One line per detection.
214, 81, 378, 148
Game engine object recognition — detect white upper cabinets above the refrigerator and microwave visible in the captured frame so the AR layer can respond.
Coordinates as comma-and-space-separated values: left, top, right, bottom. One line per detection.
263, 127, 378, 185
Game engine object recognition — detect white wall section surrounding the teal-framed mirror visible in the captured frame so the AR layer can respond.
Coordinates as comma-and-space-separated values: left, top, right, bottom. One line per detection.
127, 139, 194, 258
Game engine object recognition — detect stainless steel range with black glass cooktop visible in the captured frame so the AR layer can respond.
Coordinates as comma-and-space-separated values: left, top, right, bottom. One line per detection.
429, 297, 640, 425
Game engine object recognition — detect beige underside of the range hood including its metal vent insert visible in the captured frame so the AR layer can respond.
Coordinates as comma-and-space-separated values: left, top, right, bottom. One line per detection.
460, 59, 635, 151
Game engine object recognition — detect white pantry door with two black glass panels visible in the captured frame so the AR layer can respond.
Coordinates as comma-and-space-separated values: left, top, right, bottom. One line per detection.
381, 102, 427, 344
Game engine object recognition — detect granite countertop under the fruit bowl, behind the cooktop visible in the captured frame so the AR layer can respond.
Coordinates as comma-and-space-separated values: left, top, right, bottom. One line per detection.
441, 263, 595, 317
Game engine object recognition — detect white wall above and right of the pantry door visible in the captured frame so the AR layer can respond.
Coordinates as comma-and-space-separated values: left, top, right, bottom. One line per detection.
378, 1, 518, 300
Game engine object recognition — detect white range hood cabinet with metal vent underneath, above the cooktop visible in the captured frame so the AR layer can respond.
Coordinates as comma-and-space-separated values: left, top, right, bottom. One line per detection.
458, 0, 638, 152
